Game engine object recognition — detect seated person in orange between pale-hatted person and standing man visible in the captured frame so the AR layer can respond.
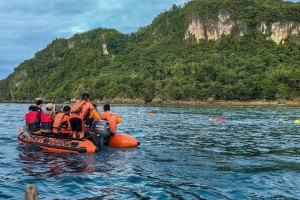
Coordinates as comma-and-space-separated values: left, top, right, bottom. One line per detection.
53, 106, 72, 137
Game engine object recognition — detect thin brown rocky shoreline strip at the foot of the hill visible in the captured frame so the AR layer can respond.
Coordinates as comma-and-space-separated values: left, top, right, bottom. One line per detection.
0, 99, 300, 108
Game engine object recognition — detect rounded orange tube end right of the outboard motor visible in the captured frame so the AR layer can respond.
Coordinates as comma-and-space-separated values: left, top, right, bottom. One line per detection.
109, 133, 140, 148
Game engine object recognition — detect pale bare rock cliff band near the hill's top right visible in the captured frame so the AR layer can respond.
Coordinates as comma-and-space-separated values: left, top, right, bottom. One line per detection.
184, 12, 300, 44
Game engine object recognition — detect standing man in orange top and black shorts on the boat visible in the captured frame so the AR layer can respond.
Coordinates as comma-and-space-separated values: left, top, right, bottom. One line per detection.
70, 93, 101, 139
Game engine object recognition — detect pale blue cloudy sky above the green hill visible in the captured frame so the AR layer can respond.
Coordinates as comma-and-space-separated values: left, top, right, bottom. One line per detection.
0, 0, 299, 80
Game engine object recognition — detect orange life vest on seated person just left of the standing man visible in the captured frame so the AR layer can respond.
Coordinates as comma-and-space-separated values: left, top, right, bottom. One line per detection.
53, 113, 72, 134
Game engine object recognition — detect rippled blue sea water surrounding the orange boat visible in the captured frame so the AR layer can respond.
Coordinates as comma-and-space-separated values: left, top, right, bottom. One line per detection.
0, 104, 300, 199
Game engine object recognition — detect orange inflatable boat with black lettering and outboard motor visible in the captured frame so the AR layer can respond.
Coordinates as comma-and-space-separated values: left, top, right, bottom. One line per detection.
18, 120, 140, 153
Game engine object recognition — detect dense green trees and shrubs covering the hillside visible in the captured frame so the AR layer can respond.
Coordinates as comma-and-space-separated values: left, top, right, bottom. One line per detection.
0, 0, 300, 102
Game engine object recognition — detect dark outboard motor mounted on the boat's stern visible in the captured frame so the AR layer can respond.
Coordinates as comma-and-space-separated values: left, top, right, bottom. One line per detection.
92, 120, 110, 150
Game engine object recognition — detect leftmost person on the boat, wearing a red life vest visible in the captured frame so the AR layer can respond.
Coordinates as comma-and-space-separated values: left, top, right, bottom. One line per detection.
25, 105, 41, 134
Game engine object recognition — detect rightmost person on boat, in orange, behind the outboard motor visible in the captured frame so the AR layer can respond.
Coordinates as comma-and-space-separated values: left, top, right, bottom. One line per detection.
101, 104, 122, 135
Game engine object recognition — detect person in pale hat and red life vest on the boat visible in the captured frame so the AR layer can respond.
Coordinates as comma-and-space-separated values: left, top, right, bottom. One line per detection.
41, 103, 55, 135
